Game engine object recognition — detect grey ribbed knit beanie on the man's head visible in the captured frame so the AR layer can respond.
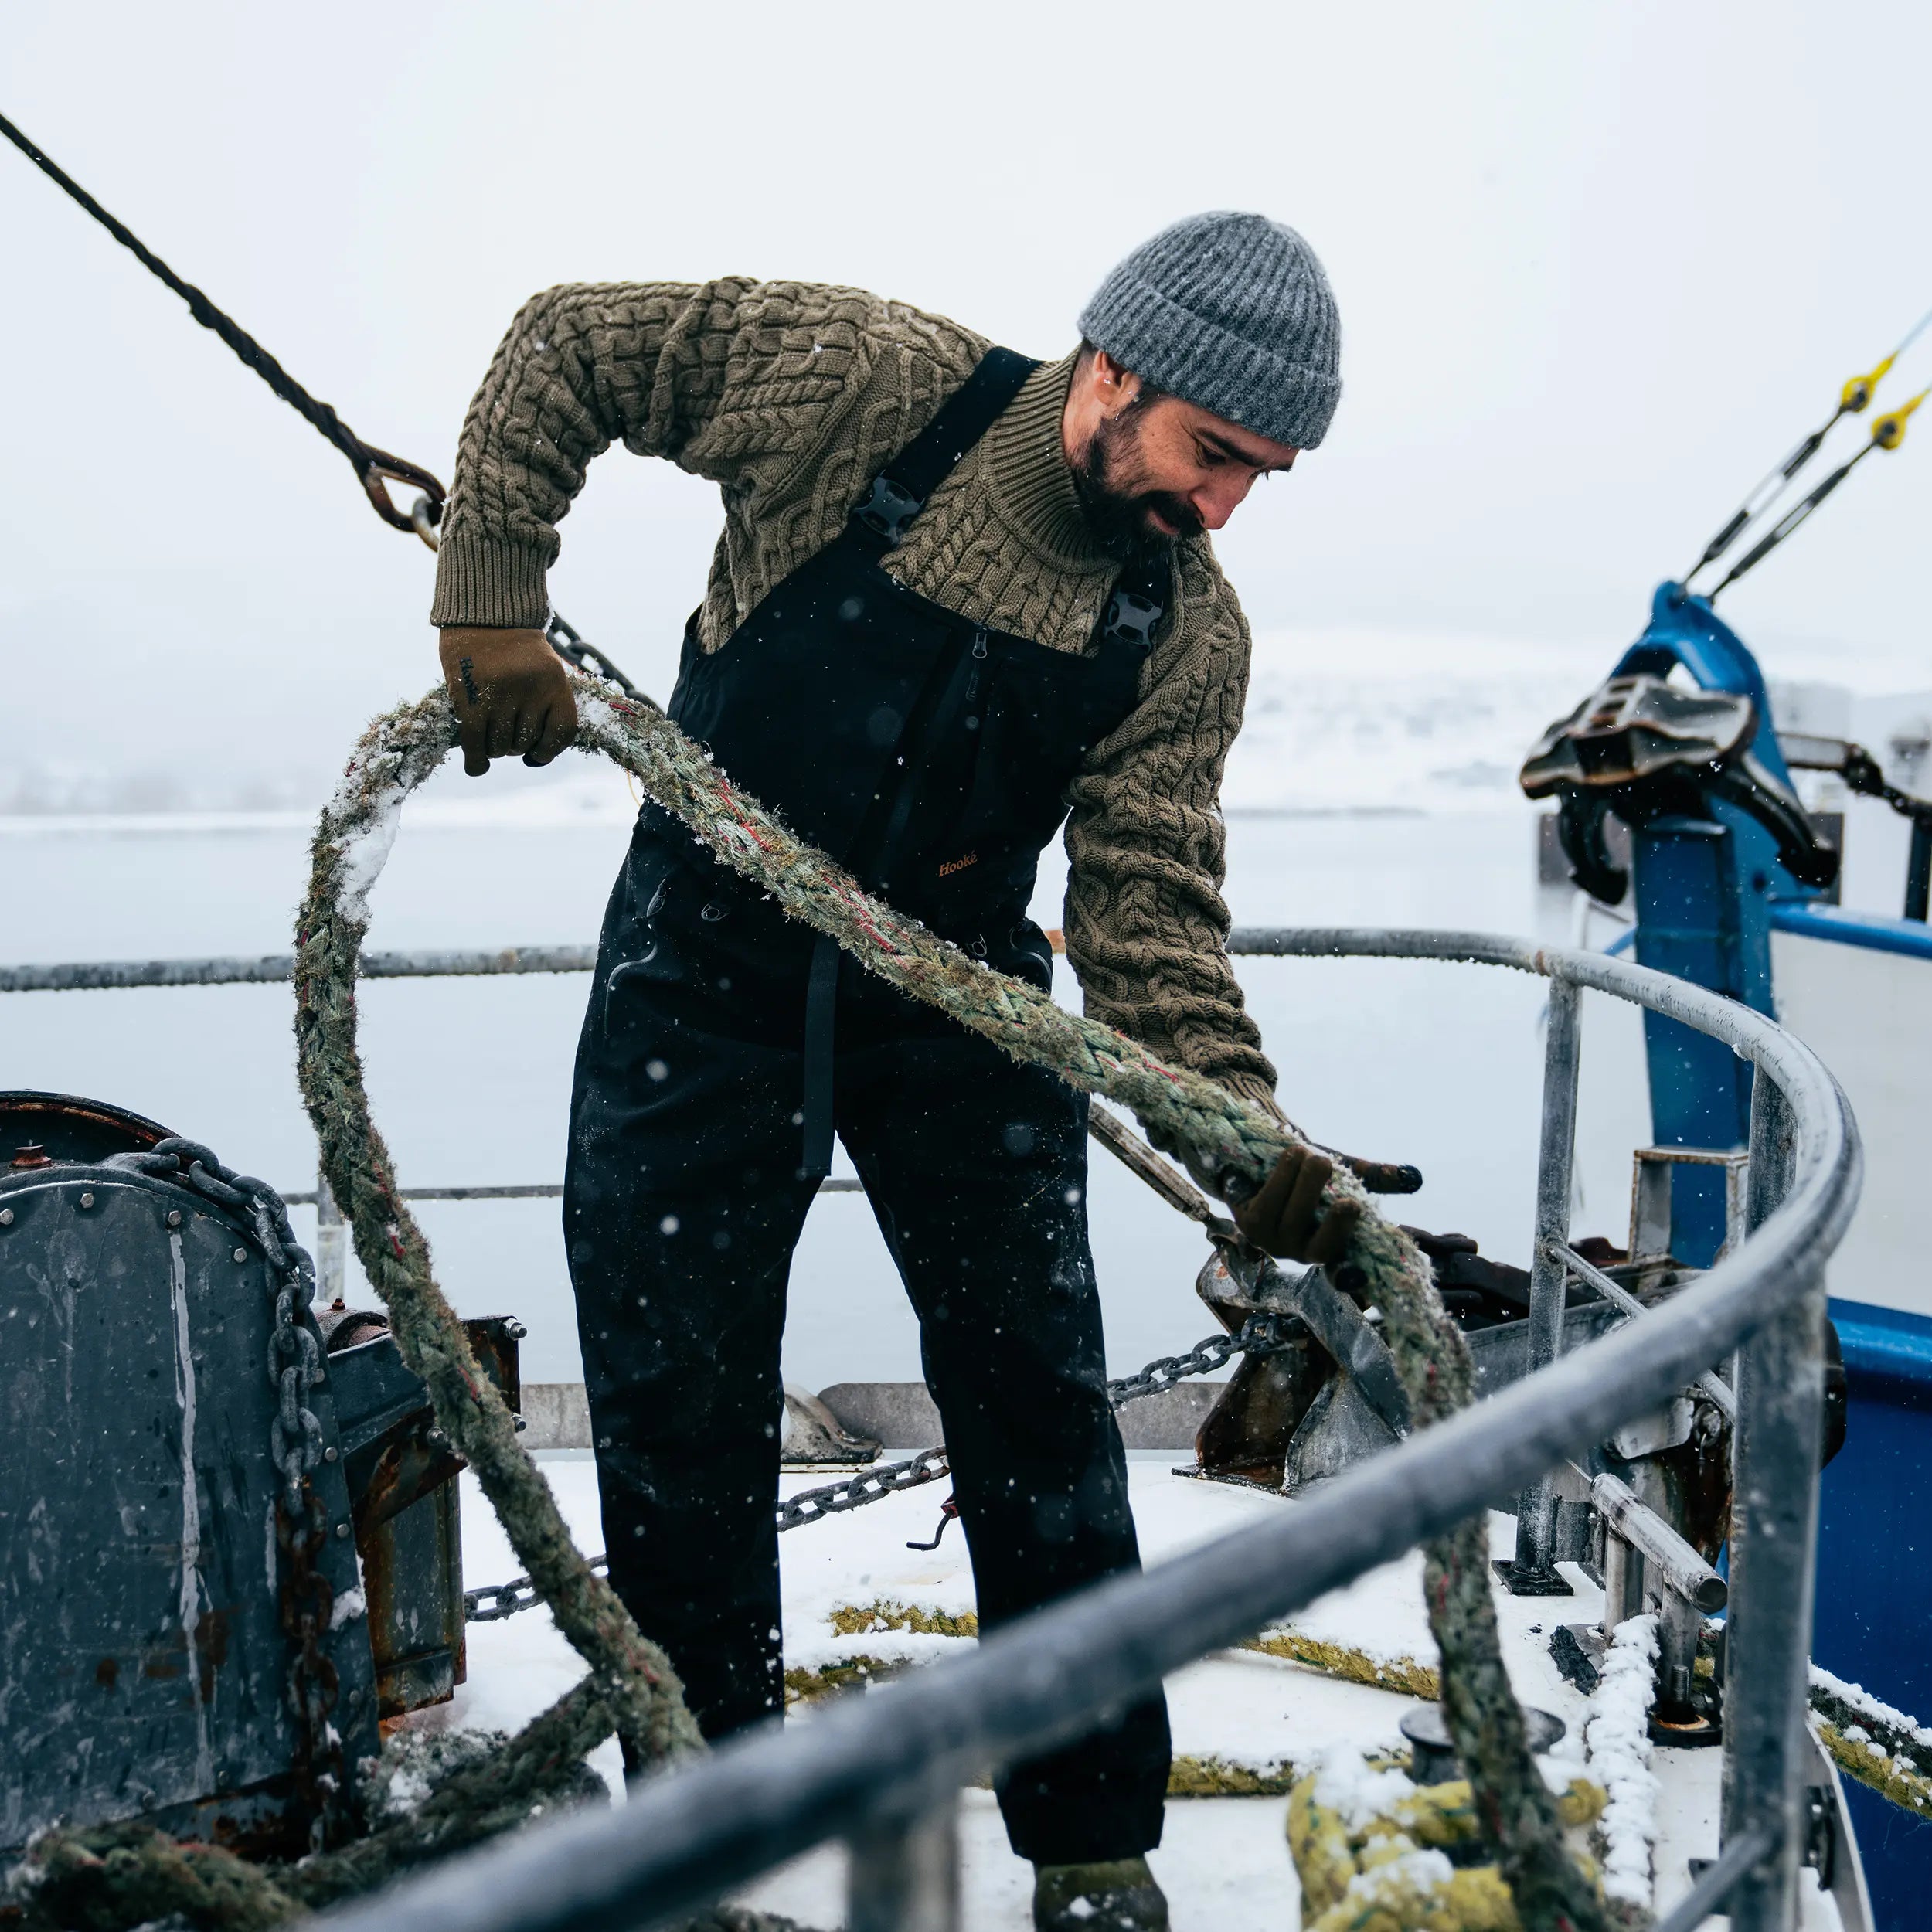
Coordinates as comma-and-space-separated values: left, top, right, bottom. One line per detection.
1080, 215, 1341, 451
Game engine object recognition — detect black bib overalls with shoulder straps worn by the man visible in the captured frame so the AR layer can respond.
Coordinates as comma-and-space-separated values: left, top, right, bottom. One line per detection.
564, 350, 1169, 1862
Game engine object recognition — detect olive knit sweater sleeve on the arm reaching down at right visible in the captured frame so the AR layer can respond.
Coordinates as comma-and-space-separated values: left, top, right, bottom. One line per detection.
1066, 545, 1279, 1113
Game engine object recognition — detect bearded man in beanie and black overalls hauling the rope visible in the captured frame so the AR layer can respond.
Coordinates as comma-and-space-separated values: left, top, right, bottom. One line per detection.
435, 215, 1349, 1928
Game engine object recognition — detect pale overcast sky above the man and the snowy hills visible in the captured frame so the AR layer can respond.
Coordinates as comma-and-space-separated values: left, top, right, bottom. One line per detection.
0, 0, 1932, 802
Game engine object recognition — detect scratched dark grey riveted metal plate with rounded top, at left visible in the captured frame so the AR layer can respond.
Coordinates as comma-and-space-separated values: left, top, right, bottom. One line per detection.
0, 1163, 377, 1849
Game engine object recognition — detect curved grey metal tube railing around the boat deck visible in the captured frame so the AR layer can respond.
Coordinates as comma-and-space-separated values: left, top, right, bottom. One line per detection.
0, 930, 1861, 1932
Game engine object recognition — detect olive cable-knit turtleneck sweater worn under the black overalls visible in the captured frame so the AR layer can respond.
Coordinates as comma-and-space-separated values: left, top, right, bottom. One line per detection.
431, 277, 1275, 1105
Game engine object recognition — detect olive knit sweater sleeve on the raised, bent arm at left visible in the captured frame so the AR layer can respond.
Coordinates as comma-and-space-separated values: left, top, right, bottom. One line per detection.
431, 278, 883, 628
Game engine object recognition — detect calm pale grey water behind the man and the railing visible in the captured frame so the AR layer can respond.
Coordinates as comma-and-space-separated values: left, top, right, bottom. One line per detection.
0, 804, 1641, 1389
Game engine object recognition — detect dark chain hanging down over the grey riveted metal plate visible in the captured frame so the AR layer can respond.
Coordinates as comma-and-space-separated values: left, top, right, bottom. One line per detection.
116, 1134, 348, 1845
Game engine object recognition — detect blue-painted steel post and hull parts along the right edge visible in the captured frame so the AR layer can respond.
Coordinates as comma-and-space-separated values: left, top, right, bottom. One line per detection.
1577, 583, 1932, 1932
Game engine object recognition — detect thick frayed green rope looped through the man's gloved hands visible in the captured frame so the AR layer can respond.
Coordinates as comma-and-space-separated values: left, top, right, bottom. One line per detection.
296, 676, 1604, 1932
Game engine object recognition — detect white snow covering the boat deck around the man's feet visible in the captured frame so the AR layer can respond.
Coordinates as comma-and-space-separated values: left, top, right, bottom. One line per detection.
434, 1453, 1770, 1932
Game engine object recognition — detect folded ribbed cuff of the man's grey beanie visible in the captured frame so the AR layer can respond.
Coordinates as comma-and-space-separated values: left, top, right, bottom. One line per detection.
1080, 269, 1341, 451
